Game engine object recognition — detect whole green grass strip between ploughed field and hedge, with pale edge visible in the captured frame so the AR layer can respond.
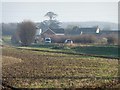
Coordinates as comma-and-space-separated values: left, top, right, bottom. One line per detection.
19, 44, 120, 57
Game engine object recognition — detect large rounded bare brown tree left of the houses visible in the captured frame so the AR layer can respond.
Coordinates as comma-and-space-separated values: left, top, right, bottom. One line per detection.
18, 21, 36, 46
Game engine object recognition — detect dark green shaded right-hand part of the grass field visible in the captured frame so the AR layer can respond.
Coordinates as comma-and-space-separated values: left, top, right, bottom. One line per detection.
72, 45, 119, 57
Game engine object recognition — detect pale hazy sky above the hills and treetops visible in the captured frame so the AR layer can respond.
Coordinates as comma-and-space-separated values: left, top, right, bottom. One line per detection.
2, 2, 118, 23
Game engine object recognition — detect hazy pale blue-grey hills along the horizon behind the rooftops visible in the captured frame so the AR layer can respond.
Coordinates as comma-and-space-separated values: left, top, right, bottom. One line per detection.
0, 21, 119, 31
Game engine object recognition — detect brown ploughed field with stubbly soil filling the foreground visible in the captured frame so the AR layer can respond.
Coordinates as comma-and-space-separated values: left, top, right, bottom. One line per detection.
2, 47, 120, 88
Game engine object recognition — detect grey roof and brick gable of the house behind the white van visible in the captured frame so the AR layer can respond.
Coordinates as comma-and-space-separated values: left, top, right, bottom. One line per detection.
41, 28, 64, 38
